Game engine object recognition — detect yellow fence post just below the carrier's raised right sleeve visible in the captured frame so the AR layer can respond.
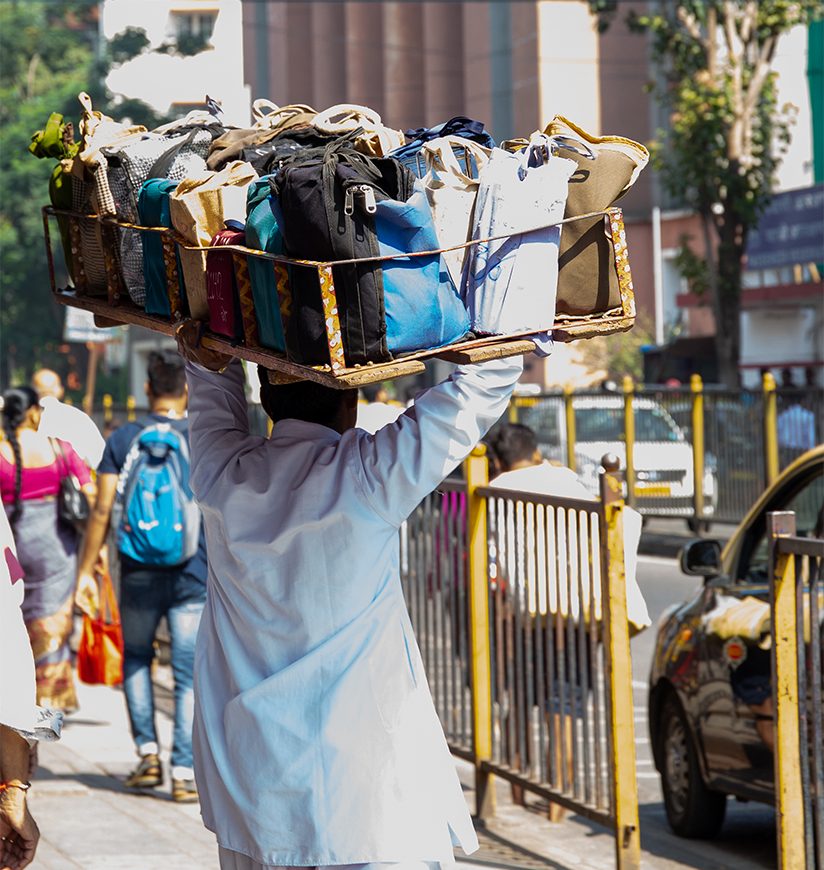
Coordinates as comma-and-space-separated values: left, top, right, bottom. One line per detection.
465, 444, 495, 819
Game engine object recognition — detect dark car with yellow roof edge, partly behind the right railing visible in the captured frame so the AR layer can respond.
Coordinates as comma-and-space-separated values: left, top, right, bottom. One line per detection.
649, 445, 824, 837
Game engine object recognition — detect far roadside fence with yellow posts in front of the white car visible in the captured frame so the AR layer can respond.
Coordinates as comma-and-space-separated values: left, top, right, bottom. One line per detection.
509, 374, 824, 529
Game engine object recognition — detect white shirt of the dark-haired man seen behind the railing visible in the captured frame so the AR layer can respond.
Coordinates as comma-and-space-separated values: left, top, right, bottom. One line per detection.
490, 462, 652, 631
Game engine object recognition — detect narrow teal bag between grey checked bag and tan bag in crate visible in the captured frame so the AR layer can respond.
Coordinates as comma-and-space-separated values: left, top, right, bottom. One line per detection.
137, 178, 186, 317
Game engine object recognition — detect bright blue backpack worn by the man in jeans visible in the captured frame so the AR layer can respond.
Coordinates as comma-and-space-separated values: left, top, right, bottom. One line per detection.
114, 423, 200, 567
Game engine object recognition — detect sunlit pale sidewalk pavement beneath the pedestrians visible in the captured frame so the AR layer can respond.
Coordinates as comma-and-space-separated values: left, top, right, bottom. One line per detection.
30, 668, 685, 870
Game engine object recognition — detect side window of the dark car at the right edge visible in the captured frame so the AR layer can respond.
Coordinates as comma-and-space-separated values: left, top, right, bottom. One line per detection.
737, 465, 824, 583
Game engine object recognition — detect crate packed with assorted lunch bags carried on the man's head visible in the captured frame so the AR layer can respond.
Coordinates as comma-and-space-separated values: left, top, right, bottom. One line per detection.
30, 94, 648, 384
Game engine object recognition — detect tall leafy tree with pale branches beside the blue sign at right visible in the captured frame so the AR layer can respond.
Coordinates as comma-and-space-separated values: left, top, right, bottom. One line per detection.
590, 0, 824, 387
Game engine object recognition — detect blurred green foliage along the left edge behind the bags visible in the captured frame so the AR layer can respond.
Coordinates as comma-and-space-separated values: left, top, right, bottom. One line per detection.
0, 0, 97, 385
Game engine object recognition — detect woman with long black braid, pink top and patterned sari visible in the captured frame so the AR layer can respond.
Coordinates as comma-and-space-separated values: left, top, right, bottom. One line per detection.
0, 387, 93, 711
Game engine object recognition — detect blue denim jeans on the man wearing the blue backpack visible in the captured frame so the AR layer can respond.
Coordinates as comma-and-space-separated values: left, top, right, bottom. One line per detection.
120, 564, 206, 768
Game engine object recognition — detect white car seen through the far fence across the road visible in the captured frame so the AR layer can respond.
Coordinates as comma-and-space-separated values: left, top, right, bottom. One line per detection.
519, 394, 718, 528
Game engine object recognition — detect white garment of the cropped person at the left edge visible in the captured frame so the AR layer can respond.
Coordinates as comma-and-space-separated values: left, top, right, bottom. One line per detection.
0, 510, 63, 744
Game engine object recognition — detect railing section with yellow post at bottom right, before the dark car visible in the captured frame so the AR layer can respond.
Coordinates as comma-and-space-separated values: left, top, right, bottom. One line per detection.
768, 511, 824, 870
